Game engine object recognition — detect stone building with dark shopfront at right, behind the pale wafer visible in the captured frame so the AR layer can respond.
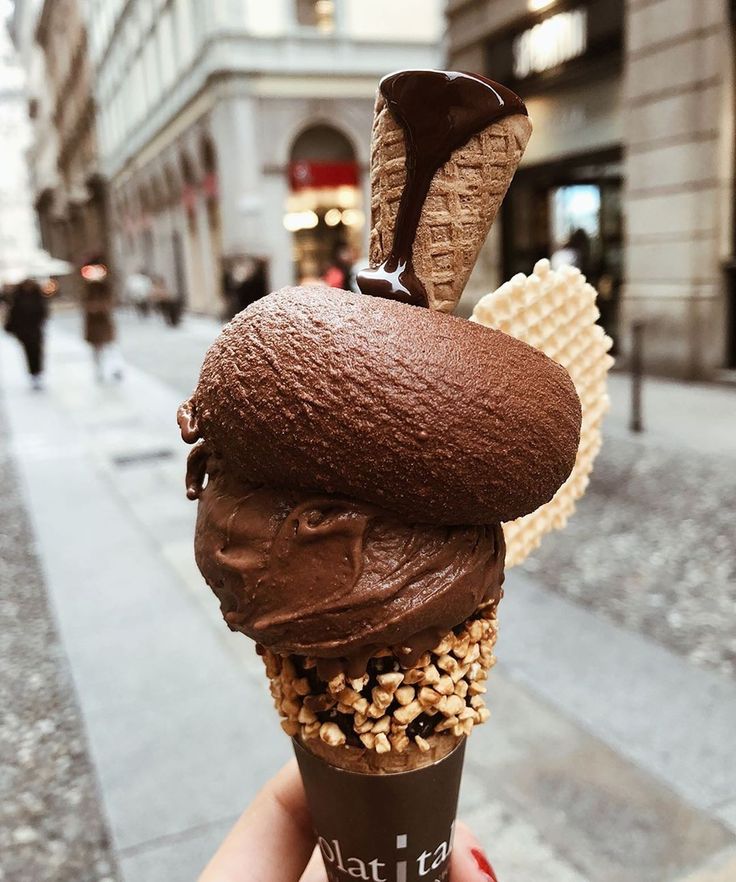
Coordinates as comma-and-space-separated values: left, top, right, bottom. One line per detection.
447, 0, 736, 379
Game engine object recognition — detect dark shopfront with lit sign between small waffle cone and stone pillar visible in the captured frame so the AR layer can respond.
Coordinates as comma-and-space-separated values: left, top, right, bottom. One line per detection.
485, 0, 624, 340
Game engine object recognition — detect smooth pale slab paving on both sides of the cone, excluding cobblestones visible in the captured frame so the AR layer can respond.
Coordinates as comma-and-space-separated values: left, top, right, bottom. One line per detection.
0, 323, 736, 882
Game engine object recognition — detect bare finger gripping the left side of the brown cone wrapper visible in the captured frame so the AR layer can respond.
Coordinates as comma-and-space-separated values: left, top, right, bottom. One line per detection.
199, 760, 315, 882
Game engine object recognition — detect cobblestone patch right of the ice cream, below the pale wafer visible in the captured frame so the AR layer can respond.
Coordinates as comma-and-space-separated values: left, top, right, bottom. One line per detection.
523, 434, 736, 676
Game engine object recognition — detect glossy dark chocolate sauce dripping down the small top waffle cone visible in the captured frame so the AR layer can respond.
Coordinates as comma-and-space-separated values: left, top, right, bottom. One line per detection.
358, 70, 527, 306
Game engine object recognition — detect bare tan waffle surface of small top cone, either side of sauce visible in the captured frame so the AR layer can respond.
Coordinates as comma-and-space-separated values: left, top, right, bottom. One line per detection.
370, 94, 531, 312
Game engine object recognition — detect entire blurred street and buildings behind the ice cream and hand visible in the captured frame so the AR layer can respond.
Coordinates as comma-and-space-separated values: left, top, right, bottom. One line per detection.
0, 0, 736, 882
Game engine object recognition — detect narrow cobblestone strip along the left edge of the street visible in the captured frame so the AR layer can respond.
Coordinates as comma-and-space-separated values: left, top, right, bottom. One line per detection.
0, 401, 118, 882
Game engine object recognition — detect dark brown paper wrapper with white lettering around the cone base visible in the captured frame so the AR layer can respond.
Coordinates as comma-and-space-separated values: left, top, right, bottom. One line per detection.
293, 738, 465, 882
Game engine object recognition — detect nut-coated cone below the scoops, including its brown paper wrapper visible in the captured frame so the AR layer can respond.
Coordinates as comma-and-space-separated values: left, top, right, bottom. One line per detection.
272, 603, 488, 882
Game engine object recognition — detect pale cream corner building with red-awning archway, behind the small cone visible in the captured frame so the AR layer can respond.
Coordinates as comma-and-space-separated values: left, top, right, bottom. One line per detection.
86, 0, 443, 314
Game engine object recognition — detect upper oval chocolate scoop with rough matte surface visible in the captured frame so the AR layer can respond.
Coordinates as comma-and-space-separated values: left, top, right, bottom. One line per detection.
186, 286, 581, 524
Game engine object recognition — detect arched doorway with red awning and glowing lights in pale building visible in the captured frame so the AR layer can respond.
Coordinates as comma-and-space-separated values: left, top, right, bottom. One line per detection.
284, 124, 365, 281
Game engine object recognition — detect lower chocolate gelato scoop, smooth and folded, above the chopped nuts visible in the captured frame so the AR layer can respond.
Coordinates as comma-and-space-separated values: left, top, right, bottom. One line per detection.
195, 455, 504, 676
